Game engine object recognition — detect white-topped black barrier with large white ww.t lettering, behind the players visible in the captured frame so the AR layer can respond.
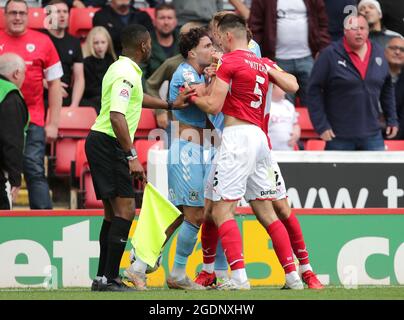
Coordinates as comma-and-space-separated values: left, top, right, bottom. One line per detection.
147, 150, 404, 209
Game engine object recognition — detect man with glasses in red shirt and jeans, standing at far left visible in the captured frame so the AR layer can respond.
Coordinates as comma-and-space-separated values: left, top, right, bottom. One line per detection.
0, 0, 63, 209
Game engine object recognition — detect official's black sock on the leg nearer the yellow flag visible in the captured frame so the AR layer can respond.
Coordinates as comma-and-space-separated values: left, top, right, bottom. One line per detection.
104, 217, 132, 281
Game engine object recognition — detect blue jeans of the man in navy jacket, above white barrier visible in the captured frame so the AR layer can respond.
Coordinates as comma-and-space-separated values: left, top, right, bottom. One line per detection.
325, 132, 385, 151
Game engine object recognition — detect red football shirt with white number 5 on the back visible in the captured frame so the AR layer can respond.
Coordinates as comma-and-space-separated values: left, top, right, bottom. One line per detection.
216, 50, 269, 128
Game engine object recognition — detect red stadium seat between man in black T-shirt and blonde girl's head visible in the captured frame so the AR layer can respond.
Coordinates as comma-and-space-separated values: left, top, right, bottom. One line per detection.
69, 7, 101, 39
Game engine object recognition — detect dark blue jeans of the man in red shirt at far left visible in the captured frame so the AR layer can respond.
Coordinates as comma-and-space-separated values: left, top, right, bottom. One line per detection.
24, 123, 52, 209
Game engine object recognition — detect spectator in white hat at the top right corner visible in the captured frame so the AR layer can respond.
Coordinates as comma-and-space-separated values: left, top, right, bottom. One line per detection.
358, 0, 401, 48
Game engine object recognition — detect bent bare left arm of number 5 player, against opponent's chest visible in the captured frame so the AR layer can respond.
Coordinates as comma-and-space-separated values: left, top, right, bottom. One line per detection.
193, 78, 230, 114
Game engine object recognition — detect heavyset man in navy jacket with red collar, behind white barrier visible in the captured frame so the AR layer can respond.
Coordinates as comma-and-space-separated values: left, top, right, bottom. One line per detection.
307, 16, 398, 150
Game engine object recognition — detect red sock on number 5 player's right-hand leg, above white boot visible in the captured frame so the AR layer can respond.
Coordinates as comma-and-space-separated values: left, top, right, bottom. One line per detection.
267, 220, 296, 274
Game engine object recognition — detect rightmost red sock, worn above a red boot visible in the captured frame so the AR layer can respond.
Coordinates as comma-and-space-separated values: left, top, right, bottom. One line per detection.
282, 213, 310, 264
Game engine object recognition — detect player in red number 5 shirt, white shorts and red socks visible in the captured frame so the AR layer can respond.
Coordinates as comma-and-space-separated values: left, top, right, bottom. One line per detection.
195, 14, 310, 290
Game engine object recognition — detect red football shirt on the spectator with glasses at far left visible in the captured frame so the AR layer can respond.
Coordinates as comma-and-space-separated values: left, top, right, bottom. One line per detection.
0, 30, 63, 126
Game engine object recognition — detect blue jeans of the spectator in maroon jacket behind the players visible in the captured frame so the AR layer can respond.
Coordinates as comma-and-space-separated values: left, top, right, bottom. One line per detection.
276, 56, 314, 106
